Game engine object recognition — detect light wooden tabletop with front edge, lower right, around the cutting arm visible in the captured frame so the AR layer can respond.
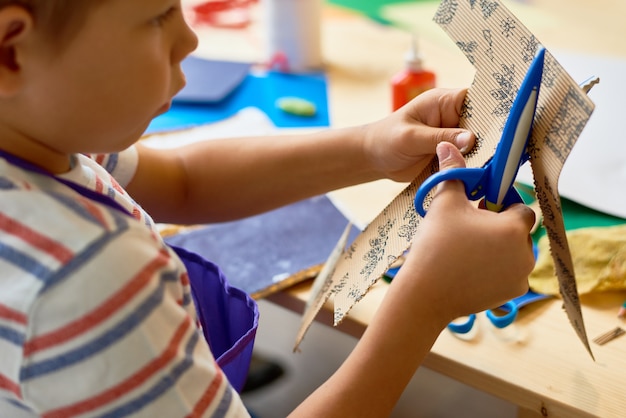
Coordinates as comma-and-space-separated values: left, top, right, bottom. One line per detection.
269, 281, 626, 418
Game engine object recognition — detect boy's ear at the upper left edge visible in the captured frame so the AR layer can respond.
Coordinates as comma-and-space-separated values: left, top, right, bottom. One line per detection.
0, 6, 33, 97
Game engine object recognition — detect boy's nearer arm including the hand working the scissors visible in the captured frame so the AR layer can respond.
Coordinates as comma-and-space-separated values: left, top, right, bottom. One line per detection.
293, 144, 534, 418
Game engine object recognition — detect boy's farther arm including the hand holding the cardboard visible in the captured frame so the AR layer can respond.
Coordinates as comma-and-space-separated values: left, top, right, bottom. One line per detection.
127, 90, 474, 223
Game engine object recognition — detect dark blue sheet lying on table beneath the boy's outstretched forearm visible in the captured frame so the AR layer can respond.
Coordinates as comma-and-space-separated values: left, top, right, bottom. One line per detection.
165, 195, 359, 294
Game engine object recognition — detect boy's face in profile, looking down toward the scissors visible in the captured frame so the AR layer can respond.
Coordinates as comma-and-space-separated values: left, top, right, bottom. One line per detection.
14, 0, 197, 158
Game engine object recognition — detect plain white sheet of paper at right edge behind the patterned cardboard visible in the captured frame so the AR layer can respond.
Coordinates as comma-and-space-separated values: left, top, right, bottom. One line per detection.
517, 50, 626, 218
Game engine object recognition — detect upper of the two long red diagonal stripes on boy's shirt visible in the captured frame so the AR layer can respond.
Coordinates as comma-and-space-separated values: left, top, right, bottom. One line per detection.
24, 250, 170, 356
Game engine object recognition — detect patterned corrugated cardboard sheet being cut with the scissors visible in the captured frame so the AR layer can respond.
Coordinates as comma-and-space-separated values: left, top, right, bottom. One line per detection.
294, 0, 594, 360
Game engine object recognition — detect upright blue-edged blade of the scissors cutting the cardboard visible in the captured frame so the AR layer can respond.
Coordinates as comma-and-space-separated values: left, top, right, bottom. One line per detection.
485, 47, 545, 212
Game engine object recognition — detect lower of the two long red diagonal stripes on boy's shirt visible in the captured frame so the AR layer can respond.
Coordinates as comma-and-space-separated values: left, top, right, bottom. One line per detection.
42, 317, 191, 418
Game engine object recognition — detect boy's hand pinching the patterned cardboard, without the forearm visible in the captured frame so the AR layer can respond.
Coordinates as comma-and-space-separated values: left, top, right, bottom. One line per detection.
365, 89, 475, 181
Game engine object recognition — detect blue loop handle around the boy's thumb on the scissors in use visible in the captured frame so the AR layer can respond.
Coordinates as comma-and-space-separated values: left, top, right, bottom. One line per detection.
414, 168, 487, 217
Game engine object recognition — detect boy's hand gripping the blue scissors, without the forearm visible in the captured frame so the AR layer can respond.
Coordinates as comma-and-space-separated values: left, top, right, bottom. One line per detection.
394, 143, 535, 321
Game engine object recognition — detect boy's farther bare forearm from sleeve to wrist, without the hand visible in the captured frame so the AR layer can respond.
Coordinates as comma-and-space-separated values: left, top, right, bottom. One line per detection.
127, 128, 376, 223
